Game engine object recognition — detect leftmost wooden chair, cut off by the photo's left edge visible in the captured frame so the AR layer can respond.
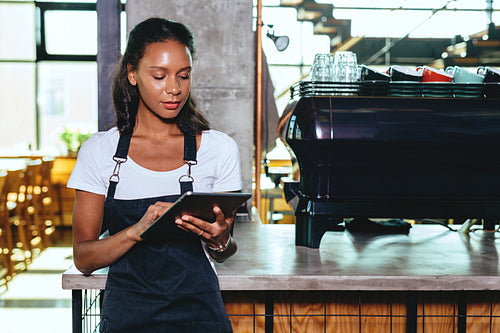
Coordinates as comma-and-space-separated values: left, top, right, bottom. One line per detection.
0, 170, 14, 288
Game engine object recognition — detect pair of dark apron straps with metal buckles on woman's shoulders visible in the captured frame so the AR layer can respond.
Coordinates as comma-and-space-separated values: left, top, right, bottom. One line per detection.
106, 133, 198, 202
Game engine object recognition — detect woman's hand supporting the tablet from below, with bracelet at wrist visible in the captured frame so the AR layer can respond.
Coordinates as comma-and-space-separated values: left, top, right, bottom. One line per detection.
175, 206, 234, 248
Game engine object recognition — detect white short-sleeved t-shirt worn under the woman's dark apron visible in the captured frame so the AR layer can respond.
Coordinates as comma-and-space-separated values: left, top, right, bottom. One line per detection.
68, 127, 242, 199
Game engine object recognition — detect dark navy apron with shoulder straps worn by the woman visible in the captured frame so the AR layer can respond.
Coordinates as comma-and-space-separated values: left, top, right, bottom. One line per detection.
100, 134, 232, 333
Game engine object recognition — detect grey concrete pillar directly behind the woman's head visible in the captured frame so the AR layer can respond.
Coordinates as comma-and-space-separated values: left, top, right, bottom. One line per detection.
126, 0, 256, 192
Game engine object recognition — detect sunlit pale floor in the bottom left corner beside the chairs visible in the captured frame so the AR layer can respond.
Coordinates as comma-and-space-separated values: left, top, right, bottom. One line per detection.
0, 230, 72, 333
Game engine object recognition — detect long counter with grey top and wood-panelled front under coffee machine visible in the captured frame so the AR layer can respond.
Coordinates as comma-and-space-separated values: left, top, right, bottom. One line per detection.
62, 222, 500, 332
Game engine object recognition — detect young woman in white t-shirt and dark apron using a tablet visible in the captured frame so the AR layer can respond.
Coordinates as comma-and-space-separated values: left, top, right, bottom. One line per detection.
68, 18, 241, 333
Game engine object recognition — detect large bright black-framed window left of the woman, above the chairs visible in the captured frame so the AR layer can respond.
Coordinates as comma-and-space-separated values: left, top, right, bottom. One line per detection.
0, 0, 126, 155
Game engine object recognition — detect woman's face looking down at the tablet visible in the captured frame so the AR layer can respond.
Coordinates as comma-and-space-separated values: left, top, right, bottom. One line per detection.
128, 40, 192, 119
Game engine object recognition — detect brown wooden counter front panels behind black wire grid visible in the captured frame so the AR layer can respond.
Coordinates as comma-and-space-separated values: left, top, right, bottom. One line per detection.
223, 291, 500, 333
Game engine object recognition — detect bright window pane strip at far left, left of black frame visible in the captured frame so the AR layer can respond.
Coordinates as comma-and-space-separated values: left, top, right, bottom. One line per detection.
0, 2, 36, 150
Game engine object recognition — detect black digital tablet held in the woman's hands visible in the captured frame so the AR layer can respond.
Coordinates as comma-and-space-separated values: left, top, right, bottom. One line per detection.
141, 192, 251, 240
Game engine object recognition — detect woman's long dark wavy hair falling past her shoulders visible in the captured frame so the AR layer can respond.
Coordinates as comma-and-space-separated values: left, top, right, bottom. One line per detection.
113, 18, 210, 134
